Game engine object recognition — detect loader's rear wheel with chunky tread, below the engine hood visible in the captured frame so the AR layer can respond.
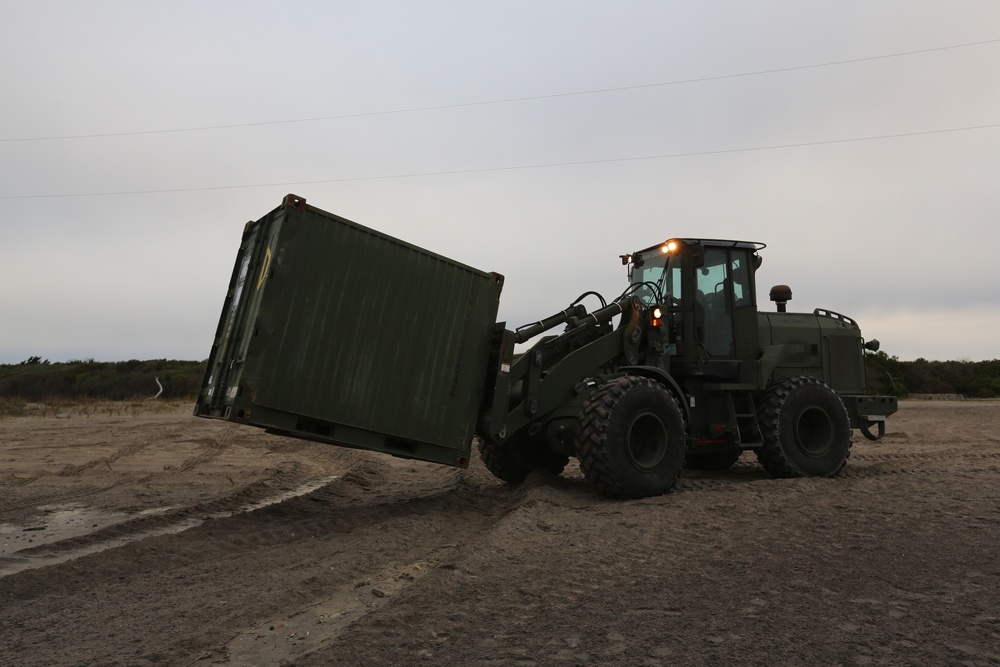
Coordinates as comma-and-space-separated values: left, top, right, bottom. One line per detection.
757, 376, 851, 477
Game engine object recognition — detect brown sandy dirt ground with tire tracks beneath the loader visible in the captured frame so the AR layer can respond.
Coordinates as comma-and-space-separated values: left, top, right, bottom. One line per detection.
0, 401, 1000, 667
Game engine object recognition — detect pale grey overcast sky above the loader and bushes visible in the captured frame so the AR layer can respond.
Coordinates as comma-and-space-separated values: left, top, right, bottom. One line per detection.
0, 0, 1000, 363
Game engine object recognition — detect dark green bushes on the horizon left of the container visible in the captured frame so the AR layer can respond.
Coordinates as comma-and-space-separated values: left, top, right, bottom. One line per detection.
0, 357, 206, 401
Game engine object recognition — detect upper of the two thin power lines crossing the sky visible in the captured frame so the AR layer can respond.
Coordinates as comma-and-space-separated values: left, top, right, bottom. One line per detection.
0, 38, 1000, 143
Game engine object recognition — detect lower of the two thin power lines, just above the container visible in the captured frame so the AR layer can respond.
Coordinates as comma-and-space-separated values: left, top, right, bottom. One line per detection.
0, 123, 1000, 199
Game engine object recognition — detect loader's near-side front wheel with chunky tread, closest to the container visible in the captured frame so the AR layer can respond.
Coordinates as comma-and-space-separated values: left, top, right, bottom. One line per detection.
577, 376, 687, 498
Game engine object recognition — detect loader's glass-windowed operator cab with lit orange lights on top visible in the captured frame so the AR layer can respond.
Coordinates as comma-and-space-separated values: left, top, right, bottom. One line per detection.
622, 239, 765, 359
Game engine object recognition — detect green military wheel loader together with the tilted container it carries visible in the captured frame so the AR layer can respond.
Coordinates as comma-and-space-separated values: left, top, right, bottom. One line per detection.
195, 195, 897, 498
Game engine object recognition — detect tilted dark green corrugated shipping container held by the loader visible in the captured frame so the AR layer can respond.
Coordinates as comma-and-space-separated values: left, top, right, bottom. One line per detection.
195, 195, 503, 467
